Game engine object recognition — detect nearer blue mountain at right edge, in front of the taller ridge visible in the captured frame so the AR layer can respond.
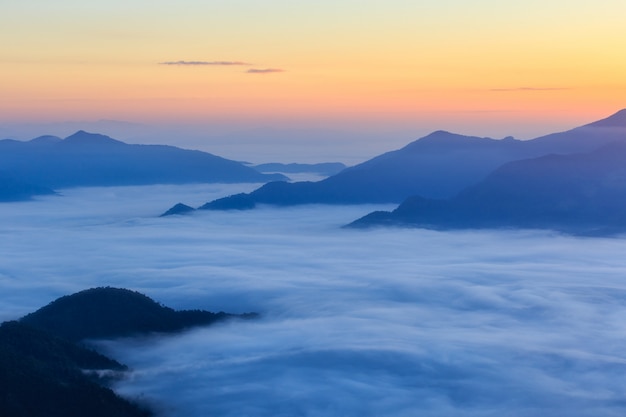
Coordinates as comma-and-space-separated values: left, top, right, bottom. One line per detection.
350, 142, 626, 236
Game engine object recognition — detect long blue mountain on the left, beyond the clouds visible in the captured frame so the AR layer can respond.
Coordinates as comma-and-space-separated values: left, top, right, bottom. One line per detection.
0, 131, 286, 188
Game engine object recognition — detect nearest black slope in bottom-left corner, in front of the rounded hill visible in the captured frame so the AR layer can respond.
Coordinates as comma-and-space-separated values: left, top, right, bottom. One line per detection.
0, 321, 152, 417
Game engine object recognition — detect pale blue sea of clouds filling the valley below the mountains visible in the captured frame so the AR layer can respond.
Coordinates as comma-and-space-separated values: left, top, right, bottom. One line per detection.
0, 184, 626, 417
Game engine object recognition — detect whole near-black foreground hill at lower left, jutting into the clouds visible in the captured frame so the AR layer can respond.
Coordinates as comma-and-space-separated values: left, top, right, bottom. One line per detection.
0, 288, 255, 417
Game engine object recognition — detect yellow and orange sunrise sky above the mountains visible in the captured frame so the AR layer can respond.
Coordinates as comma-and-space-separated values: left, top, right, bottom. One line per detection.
0, 0, 626, 161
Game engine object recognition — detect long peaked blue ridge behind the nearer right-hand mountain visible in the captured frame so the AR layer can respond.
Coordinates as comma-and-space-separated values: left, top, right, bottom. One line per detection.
189, 110, 626, 209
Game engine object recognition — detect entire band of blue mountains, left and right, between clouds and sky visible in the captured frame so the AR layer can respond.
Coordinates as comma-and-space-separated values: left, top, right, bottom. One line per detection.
6, 109, 626, 234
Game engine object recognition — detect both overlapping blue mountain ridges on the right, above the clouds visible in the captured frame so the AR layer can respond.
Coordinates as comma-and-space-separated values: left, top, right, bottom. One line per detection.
167, 109, 626, 234
